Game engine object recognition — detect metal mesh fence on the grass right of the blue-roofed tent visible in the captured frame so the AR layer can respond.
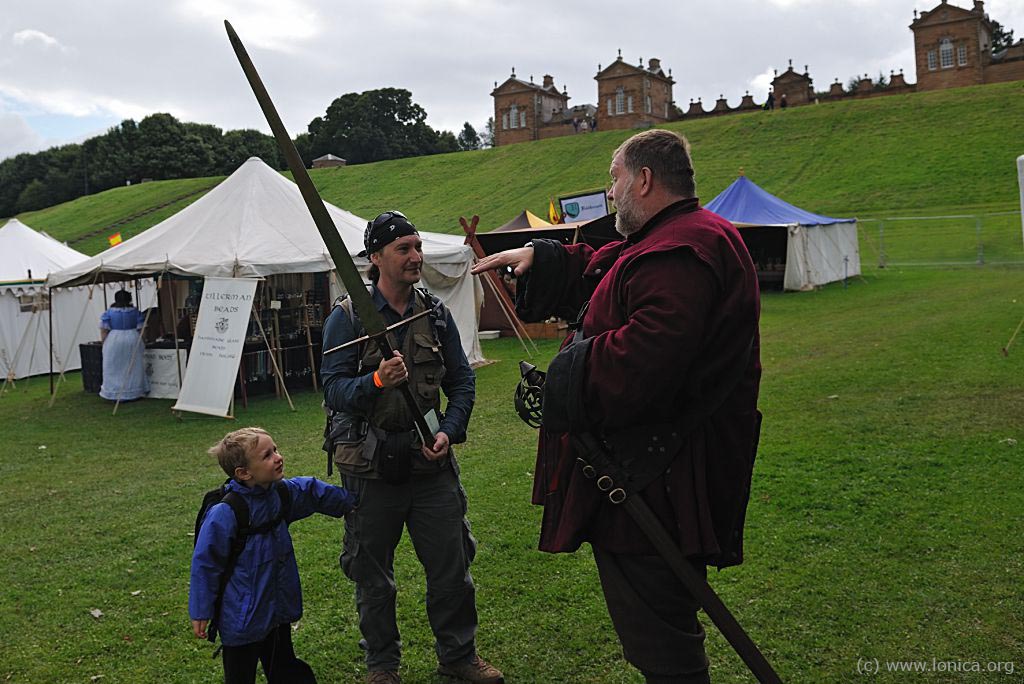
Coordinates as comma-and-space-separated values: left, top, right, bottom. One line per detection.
857, 211, 1024, 268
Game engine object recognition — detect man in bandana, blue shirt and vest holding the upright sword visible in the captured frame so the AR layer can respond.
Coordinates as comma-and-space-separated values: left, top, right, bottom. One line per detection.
321, 211, 504, 684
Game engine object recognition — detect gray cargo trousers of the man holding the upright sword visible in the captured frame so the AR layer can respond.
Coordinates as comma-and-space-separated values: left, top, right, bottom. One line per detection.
340, 467, 477, 672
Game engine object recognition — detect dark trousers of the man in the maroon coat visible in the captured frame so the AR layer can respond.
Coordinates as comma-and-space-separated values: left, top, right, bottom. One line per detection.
594, 547, 711, 684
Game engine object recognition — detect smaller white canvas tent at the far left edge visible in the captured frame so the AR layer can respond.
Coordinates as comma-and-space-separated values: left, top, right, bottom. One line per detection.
0, 218, 153, 380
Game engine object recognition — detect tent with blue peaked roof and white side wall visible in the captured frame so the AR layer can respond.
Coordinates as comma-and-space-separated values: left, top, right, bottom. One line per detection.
705, 176, 860, 290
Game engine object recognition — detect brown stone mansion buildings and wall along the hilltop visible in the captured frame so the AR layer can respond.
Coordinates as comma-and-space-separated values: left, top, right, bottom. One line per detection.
490, 0, 1024, 146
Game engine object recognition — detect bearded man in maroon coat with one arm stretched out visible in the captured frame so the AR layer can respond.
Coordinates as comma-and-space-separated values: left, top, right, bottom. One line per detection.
474, 129, 761, 683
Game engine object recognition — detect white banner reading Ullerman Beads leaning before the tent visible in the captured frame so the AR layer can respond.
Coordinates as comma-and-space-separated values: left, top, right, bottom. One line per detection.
172, 277, 258, 417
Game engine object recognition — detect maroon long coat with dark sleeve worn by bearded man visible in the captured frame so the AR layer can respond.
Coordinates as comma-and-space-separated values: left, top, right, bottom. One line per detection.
519, 199, 761, 566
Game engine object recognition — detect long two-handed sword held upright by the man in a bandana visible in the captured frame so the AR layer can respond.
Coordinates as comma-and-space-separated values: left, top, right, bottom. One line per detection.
224, 19, 433, 444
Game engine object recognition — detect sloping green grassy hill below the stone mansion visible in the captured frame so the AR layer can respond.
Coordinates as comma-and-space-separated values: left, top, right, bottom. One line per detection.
14, 78, 1024, 254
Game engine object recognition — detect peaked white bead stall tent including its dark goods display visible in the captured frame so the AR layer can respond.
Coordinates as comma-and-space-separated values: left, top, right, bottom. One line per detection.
48, 158, 482, 409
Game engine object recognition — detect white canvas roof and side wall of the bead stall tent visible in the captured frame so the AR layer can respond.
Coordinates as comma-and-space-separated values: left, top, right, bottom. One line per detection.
48, 157, 483, 364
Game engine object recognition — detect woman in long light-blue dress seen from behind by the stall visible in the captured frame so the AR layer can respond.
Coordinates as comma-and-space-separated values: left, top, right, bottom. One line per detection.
99, 290, 150, 401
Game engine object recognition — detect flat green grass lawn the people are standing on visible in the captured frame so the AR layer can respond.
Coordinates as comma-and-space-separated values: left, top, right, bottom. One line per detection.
0, 260, 1024, 684
